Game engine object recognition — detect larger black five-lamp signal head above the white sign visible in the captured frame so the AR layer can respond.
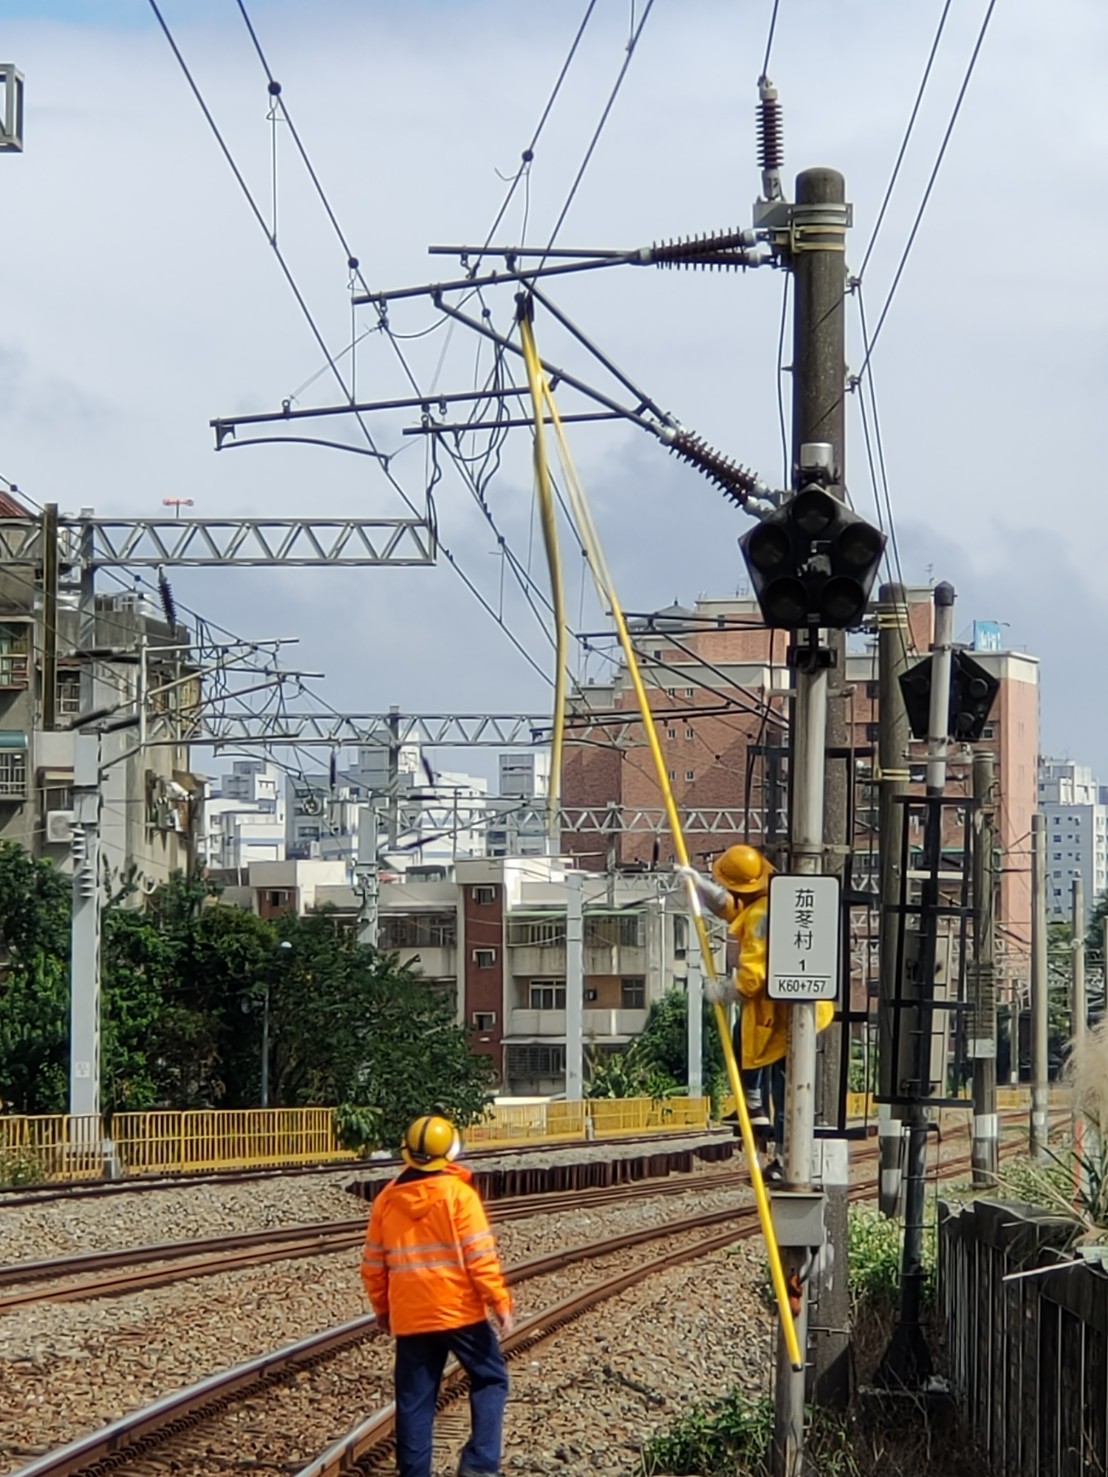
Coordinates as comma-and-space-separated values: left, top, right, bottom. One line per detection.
739, 483, 885, 631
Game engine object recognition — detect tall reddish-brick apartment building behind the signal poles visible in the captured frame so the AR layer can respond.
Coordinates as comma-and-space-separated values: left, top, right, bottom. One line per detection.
563, 586, 1039, 1007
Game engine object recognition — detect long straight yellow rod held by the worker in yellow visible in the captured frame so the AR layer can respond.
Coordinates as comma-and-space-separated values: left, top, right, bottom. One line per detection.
520, 319, 804, 1371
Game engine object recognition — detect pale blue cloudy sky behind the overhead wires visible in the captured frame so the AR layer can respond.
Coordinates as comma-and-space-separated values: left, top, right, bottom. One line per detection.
0, 0, 1108, 781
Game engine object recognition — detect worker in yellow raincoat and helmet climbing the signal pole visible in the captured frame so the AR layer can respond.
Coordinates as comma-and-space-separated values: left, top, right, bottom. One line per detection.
680, 846, 835, 1183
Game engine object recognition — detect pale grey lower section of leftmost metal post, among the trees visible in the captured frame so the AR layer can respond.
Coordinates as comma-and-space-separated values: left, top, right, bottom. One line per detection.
69, 733, 100, 1143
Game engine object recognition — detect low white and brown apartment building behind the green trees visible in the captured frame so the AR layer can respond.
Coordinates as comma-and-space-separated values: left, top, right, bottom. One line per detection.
241, 857, 712, 1096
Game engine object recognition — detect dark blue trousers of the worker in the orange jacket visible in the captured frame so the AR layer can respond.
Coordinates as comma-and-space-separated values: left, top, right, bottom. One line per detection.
394, 1320, 508, 1477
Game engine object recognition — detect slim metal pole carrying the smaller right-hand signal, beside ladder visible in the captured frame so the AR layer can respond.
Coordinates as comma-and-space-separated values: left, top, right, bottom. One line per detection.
878, 582, 954, 1388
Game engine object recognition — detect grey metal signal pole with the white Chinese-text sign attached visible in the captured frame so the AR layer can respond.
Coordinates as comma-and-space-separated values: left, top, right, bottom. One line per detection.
774, 648, 827, 1477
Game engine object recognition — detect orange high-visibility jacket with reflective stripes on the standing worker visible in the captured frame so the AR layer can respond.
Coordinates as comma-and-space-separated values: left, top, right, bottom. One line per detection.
362, 1165, 511, 1334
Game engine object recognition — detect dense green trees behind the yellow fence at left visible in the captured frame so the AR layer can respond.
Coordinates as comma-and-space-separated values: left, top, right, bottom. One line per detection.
0, 845, 492, 1140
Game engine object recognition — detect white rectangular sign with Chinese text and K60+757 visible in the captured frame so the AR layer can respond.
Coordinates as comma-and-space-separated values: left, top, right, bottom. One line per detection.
765, 871, 842, 1000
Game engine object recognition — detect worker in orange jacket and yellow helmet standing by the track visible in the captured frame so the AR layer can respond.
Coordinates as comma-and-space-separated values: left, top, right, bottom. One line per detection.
362, 1114, 514, 1477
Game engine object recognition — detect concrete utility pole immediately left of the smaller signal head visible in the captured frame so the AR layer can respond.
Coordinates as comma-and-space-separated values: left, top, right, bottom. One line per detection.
878, 585, 912, 1216
